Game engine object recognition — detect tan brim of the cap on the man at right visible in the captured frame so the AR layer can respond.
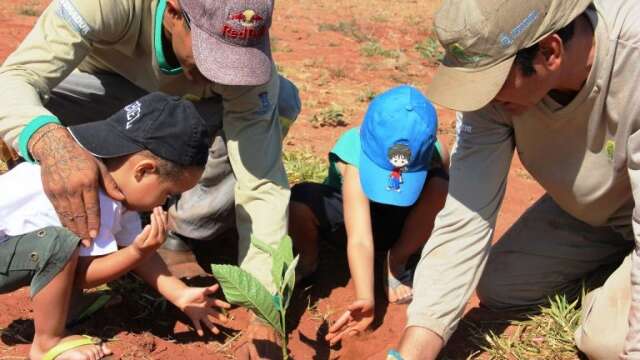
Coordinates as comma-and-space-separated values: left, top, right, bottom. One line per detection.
425, 56, 515, 111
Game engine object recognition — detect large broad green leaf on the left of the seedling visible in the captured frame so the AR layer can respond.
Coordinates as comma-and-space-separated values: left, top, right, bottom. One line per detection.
211, 264, 282, 332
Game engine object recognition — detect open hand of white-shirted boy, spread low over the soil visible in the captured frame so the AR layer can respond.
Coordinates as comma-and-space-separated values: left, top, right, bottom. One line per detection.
175, 284, 231, 336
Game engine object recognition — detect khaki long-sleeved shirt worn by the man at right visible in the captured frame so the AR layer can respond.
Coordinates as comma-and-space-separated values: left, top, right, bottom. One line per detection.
408, 0, 640, 352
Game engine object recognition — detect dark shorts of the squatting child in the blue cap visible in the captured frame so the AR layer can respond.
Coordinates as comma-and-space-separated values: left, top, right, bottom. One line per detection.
291, 169, 449, 251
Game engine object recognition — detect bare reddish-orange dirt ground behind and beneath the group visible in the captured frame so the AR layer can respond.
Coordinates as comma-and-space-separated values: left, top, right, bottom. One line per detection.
0, 0, 542, 359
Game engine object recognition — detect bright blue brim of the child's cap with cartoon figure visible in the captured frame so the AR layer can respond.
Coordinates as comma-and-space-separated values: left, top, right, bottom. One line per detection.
359, 147, 428, 206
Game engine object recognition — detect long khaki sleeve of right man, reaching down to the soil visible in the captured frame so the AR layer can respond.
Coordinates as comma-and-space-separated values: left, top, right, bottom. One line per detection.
407, 107, 514, 342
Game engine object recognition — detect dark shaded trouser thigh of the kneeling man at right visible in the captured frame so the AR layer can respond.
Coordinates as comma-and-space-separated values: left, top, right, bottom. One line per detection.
477, 195, 633, 310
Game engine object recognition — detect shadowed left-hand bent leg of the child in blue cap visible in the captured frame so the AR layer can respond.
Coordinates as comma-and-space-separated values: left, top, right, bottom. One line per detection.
289, 183, 344, 279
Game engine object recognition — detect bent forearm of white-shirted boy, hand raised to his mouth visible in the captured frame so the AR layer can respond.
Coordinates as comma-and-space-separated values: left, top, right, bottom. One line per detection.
76, 207, 167, 289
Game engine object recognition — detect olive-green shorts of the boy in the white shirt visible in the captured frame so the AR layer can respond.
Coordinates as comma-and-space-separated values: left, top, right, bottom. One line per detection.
0, 227, 80, 297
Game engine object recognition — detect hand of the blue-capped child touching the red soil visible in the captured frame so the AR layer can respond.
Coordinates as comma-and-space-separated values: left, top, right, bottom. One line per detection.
325, 300, 374, 345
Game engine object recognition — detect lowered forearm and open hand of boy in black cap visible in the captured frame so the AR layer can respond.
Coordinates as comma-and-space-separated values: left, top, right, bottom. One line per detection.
133, 253, 231, 336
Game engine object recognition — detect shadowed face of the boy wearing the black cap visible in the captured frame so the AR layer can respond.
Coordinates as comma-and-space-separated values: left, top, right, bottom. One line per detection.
118, 159, 204, 211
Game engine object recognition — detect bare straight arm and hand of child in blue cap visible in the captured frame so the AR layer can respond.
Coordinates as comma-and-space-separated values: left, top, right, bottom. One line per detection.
326, 165, 375, 344
